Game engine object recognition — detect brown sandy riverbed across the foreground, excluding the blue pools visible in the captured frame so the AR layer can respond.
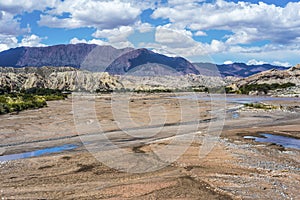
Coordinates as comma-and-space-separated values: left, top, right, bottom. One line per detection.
0, 94, 300, 199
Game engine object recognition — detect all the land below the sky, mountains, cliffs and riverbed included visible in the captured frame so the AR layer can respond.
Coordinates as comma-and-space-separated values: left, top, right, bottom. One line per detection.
0, 44, 300, 199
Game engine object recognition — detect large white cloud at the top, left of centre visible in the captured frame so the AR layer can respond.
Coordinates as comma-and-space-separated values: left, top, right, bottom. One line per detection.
38, 0, 141, 29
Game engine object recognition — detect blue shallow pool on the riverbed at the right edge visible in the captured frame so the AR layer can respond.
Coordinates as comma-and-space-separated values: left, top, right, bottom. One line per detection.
244, 133, 300, 150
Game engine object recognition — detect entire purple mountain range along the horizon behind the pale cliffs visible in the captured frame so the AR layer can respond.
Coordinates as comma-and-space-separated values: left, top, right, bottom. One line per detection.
0, 44, 286, 77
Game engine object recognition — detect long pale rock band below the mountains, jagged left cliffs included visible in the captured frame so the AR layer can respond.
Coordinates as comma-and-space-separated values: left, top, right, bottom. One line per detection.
0, 67, 236, 92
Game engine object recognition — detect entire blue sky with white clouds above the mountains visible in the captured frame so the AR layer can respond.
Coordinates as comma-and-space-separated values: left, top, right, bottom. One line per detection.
0, 0, 300, 67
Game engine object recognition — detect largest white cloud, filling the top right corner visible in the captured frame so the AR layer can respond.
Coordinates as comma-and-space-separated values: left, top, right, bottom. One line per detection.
152, 0, 300, 44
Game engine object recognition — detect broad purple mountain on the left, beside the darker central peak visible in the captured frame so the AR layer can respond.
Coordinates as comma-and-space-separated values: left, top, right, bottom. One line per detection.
0, 44, 133, 71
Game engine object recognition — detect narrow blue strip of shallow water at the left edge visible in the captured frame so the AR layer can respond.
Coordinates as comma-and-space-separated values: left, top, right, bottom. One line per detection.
0, 144, 78, 162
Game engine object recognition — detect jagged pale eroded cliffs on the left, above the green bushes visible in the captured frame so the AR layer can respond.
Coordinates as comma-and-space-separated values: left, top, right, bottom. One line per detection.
0, 67, 123, 92
